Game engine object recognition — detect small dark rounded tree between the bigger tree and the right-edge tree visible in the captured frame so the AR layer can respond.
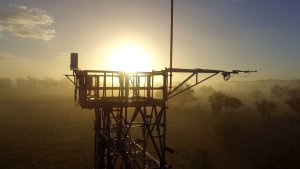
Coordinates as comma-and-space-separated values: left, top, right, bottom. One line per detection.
255, 99, 278, 120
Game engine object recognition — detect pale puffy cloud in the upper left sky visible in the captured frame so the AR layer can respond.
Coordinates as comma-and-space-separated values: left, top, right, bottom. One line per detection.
0, 4, 55, 40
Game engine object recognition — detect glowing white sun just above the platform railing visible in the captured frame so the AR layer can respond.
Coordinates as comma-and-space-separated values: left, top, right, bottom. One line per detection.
108, 44, 152, 72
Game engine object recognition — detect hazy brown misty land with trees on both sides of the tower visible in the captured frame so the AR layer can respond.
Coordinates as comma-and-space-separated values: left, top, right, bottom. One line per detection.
0, 77, 300, 169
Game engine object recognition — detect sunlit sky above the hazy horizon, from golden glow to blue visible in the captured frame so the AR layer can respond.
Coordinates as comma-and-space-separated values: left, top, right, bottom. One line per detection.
0, 0, 300, 80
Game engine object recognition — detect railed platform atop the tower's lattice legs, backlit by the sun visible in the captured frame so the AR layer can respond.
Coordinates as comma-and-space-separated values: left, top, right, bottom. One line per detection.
74, 70, 167, 109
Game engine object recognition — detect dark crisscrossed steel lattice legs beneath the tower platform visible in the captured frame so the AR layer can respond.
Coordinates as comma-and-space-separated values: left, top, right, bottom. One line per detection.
94, 106, 166, 169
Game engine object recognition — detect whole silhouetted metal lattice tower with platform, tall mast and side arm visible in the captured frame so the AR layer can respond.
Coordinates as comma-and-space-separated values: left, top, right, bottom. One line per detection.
66, 0, 256, 169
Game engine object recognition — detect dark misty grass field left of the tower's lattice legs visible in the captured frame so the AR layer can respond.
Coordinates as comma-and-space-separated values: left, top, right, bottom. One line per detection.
0, 97, 93, 169
